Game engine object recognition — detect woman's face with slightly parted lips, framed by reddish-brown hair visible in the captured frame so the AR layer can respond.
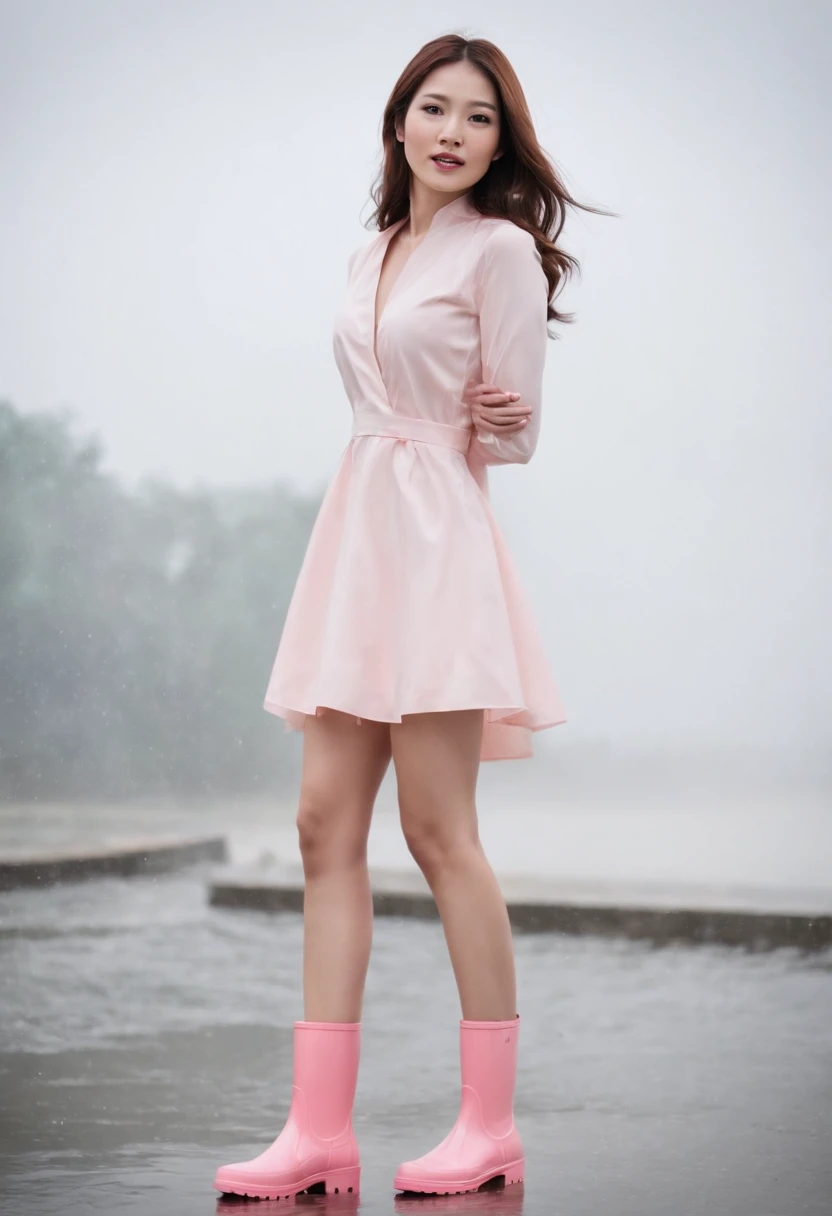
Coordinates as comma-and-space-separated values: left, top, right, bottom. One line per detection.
395, 61, 500, 193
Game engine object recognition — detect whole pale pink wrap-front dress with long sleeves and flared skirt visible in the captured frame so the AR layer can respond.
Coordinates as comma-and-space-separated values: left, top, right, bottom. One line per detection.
265, 195, 566, 760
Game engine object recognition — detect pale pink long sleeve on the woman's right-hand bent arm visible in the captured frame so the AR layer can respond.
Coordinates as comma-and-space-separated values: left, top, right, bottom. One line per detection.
468, 223, 549, 465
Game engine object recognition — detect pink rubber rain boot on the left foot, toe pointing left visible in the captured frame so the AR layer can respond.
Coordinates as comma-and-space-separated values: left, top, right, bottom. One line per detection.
214, 1021, 361, 1199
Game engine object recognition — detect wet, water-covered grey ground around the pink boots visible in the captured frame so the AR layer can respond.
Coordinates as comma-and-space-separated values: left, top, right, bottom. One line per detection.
0, 868, 832, 1216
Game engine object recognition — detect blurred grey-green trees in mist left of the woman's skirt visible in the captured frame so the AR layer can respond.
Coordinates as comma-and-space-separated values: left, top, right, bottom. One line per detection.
0, 401, 320, 799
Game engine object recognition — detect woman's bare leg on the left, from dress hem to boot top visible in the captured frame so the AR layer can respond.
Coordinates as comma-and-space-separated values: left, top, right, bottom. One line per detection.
298, 709, 390, 1021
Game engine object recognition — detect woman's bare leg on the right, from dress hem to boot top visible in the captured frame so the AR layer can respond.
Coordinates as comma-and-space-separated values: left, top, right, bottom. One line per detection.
389, 709, 517, 1021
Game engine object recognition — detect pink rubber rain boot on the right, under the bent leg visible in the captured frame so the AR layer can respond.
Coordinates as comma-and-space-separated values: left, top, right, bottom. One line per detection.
394, 1018, 525, 1195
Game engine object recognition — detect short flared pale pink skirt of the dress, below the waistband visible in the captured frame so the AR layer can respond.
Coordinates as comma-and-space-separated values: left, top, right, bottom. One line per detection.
264, 435, 566, 760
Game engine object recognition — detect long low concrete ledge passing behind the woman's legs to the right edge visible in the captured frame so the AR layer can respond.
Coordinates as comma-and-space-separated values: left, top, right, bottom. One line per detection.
208, 867, 832, 951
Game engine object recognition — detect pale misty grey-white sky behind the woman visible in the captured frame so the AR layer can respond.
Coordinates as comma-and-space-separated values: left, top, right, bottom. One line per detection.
0, 0, 832, 749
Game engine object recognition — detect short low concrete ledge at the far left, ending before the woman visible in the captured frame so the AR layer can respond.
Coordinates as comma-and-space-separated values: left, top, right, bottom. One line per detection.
0, 837, 227, 890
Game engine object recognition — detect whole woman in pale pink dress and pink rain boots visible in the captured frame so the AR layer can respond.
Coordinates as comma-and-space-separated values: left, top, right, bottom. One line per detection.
214, 35, 603, 1198
